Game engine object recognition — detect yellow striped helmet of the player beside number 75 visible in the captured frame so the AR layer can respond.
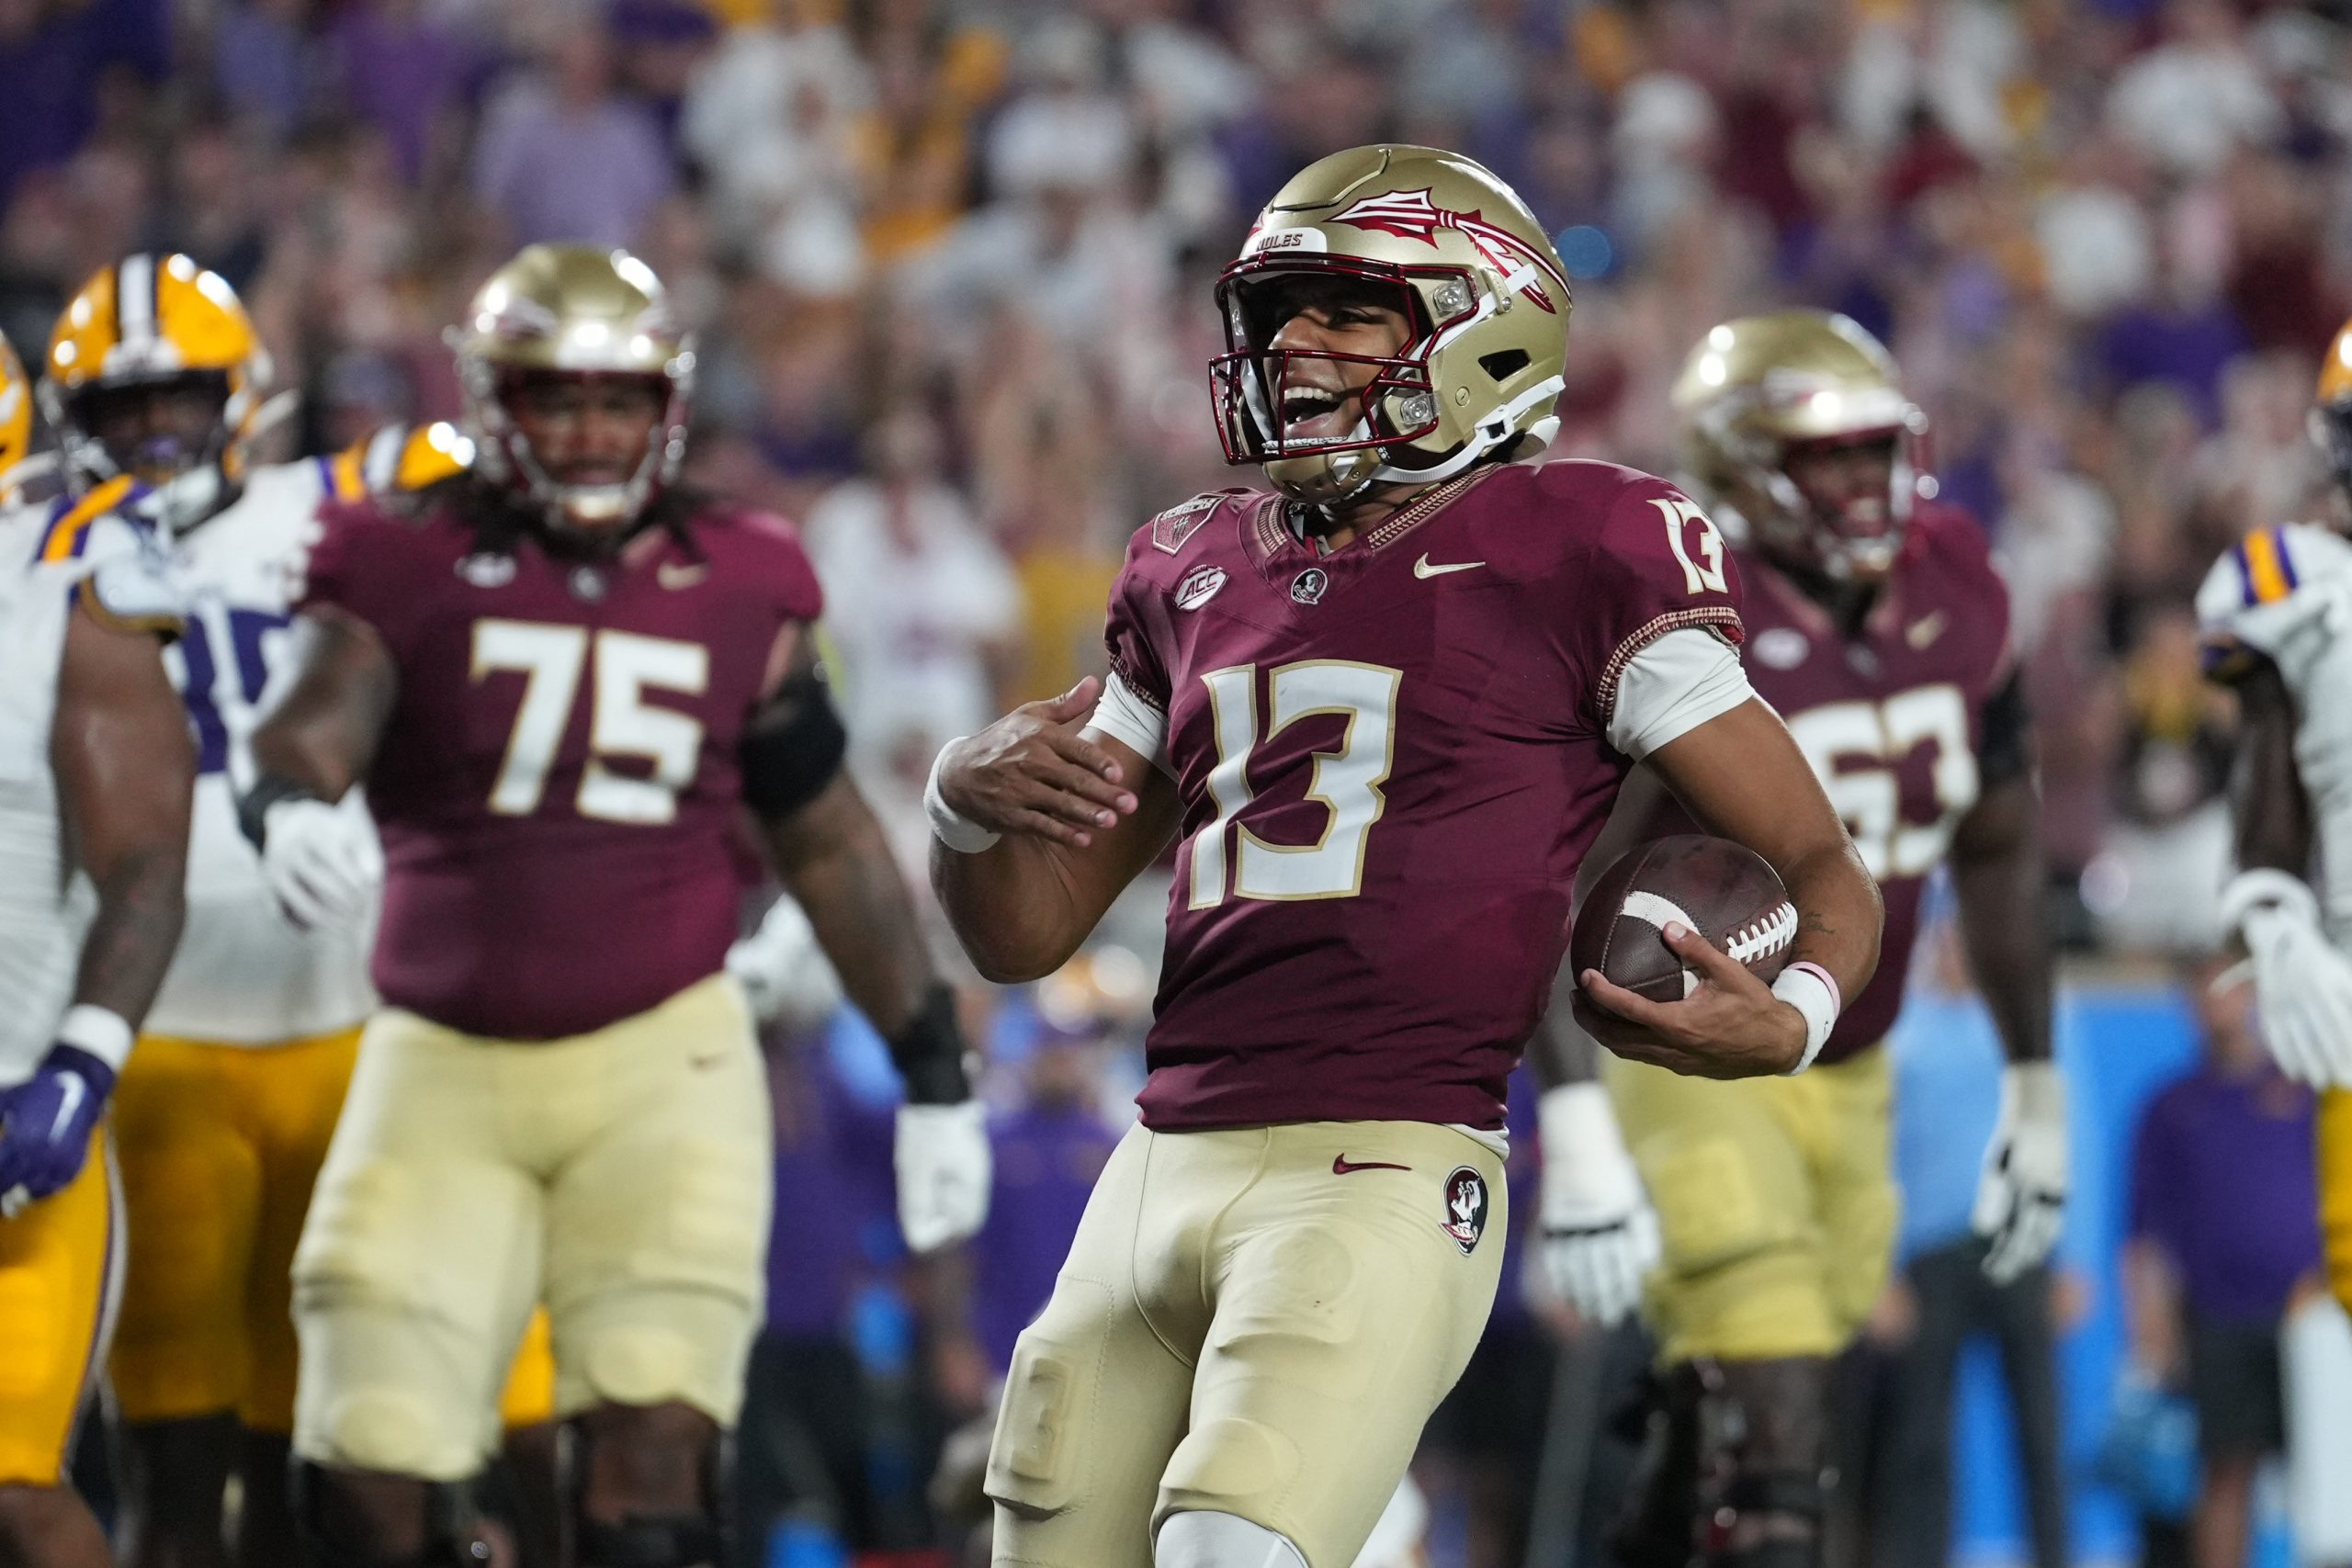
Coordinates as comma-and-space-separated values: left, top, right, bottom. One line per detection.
40, 254, 270, 529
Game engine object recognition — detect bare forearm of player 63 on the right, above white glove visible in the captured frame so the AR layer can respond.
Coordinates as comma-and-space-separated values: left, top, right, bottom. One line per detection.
1950, 773, 2051, 1063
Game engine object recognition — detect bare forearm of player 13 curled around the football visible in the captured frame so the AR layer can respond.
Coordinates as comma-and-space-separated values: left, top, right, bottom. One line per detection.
1649, 701, 1886, 1001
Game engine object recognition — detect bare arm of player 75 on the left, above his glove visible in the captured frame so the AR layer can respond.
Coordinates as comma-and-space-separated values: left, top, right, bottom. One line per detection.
252, 604, 400, 802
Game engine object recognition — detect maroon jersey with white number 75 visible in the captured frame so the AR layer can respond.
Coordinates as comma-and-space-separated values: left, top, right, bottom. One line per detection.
303, 501, 820, 1039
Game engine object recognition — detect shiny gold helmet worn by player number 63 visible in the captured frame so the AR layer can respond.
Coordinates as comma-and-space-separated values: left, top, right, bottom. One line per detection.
1672, 310, 1927, 583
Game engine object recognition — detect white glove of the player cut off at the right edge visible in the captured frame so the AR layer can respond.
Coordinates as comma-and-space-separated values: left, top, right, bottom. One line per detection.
2221, 870, 2352, 1086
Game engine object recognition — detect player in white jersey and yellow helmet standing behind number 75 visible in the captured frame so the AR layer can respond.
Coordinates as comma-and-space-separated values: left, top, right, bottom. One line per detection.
40, 254, 553, 1568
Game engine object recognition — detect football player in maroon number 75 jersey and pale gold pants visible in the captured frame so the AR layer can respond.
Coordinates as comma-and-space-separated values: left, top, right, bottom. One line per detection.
243, 247, 988, 1568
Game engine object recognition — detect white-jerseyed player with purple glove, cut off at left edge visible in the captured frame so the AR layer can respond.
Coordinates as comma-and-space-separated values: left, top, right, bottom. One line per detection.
0, 413, 195, 1568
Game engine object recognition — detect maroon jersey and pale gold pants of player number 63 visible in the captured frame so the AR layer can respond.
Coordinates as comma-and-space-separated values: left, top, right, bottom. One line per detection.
1601, 503, 2011, 1361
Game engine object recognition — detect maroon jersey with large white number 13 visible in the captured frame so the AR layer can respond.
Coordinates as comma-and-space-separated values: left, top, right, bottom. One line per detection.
1110, 463, 1740, 1128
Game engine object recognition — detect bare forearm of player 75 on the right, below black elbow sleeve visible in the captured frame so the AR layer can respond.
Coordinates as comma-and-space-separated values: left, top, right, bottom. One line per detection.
762, 773, 938, 1039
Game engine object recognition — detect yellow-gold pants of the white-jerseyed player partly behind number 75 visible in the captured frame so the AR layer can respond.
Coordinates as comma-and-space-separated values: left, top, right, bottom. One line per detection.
110, 1027, 555, 1437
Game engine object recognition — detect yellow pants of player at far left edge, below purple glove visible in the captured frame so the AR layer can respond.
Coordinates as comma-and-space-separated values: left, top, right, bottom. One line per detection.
0, 1128, 122, 1485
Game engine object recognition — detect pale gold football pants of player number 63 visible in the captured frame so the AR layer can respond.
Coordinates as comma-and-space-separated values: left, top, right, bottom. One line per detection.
1601, 1048, 1895, 1363
